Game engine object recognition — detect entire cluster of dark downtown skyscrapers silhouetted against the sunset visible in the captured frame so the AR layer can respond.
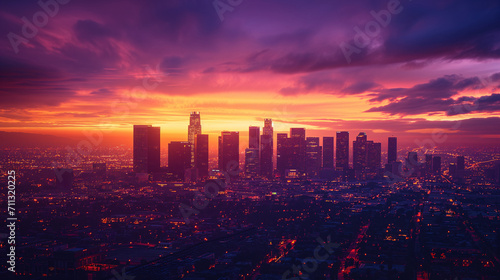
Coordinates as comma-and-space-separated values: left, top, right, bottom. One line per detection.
133, 112, 464, 180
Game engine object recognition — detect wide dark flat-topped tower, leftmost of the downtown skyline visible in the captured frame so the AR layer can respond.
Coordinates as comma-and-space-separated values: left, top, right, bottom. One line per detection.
133, 125, 160, 173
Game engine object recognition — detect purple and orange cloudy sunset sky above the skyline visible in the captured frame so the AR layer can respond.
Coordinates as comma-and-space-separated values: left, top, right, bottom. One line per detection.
0, 0, 500, 148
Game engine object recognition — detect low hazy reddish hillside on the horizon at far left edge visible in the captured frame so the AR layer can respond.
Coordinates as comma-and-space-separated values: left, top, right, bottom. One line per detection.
0, 131, 76, 148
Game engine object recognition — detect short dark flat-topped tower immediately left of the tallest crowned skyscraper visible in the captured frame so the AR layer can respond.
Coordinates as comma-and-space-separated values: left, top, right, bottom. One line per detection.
168, 141, 191, 180
